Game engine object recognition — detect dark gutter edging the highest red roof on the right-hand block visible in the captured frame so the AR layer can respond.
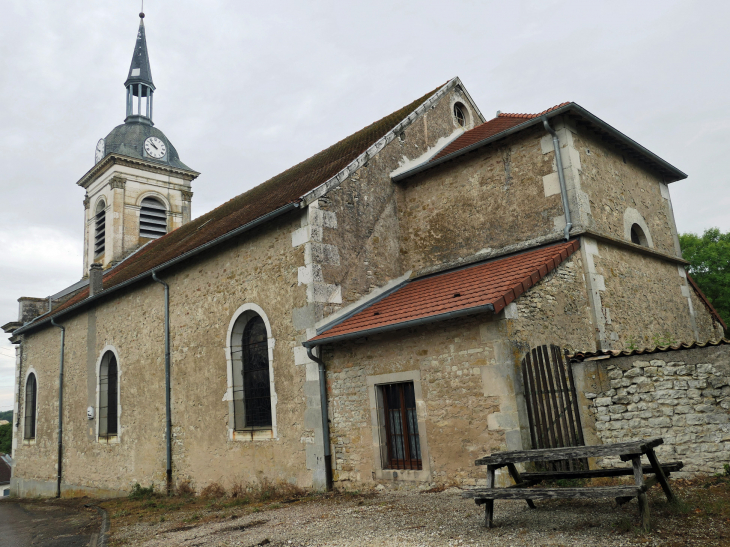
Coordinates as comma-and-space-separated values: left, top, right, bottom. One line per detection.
391, 103, 687, 183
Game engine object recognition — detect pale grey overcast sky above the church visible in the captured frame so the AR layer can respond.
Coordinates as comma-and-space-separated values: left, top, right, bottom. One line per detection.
0, 0, 730, 410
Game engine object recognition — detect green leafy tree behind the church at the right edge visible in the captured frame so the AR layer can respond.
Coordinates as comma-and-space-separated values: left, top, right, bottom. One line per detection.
679, 228, 730, 325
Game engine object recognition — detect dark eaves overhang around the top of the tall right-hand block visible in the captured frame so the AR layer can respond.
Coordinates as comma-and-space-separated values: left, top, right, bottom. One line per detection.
392, 103, 687, 183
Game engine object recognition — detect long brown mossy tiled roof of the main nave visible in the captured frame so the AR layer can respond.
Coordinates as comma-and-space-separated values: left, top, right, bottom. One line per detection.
48, 86, 442, 322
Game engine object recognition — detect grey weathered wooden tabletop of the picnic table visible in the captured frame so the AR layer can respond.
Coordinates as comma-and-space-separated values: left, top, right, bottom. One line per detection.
474, 437, 664, 466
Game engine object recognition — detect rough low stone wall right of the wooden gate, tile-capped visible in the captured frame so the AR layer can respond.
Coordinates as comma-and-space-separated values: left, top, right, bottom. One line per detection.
574, 345, 730, 477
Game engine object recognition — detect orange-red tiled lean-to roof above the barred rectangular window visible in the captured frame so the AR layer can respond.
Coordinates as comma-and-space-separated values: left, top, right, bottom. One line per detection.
308, 240, 579, 345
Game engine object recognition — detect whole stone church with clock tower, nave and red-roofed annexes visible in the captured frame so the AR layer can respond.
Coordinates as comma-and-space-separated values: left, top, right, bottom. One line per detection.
4, 15, 724, 496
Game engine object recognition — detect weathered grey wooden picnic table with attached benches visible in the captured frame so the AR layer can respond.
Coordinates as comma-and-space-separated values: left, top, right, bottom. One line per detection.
463, 437, 683, 530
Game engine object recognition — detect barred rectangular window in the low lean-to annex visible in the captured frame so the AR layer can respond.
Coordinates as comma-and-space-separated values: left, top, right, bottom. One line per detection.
380, 382, 423, 469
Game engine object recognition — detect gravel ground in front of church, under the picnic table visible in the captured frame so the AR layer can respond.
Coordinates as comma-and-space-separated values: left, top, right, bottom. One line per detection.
105, 488, 730, 547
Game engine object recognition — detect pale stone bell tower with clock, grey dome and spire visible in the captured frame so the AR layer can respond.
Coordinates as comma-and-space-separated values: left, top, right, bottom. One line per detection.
77, 13, 200, 276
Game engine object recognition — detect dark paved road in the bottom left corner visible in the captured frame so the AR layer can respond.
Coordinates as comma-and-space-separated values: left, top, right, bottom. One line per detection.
0, 500, 101, 547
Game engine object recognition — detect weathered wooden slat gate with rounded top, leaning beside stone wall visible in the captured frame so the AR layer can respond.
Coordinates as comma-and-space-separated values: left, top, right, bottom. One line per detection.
522, 345, 588, 471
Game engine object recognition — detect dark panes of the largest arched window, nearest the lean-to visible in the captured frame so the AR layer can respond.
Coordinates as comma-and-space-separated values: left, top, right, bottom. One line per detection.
234, 315, 271, 431
